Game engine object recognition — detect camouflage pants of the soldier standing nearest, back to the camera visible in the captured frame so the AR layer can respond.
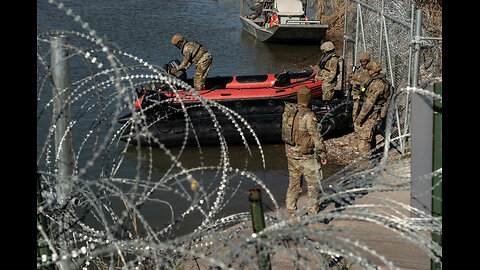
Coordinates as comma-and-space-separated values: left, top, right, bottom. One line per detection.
286, 158, 323, 215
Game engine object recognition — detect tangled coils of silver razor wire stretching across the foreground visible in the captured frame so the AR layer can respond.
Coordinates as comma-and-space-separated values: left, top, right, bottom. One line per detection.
37, 0, 442, 269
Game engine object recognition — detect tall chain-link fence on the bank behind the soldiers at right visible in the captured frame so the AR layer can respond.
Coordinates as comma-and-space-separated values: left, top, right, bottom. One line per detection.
343, 0, 442, 153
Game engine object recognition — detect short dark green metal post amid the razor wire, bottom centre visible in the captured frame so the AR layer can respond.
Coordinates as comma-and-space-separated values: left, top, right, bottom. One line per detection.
248, 187, 272, 270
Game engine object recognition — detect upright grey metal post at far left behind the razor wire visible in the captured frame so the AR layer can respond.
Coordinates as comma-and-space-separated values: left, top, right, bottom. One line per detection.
50, 36, 74, 204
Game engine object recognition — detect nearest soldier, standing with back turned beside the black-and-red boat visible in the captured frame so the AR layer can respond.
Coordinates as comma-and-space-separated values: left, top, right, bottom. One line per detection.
282, 86, 327, 216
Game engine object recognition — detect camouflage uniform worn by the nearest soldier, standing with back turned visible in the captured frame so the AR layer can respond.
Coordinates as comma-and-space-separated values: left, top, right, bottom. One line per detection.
285, 90, 326, 215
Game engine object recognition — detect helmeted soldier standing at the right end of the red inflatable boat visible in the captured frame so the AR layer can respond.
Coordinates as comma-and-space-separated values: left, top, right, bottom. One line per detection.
314, 41, 340, 100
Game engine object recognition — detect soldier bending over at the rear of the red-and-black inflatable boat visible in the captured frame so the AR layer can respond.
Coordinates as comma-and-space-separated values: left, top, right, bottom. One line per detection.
170, 34, 212, 91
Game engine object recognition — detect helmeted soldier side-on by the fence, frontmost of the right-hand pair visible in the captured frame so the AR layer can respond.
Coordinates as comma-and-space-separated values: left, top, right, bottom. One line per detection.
354, 61, 392, 155
